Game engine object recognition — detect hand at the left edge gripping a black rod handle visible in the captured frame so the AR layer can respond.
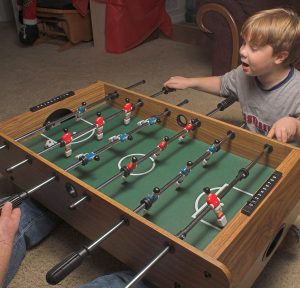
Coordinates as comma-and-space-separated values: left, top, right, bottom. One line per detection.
0, 202, 21, 248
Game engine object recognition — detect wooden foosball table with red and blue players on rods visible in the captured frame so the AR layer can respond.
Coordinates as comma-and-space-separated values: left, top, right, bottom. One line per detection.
0, 81, 300, 288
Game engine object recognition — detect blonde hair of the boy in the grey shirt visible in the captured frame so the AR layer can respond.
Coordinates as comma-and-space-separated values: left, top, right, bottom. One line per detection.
241, 8, 300, 64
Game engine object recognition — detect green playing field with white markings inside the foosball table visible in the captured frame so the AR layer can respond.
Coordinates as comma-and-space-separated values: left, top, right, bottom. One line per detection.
24, 105, 273, 249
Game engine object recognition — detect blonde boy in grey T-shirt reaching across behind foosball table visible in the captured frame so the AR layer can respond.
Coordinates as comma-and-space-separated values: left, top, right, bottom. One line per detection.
164, 8, 300, 144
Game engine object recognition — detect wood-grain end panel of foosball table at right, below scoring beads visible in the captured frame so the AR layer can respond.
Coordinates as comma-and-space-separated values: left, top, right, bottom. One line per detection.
205, 150, 300, 288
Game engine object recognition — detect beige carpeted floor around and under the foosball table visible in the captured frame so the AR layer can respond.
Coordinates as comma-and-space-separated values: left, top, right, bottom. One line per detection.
0, 23, 300, 288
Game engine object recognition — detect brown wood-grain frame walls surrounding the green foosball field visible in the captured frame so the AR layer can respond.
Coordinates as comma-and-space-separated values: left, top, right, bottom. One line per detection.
0, 81, 300, 288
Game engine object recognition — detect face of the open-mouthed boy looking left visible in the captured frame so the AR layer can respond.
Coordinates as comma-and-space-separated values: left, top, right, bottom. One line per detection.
240, 39, 277, 76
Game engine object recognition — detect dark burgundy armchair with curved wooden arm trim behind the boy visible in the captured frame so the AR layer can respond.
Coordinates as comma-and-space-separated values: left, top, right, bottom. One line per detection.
197, 0, 300, 75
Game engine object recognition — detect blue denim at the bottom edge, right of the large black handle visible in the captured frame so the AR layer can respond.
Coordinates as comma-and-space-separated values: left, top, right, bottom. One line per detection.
79, 271, 154, 288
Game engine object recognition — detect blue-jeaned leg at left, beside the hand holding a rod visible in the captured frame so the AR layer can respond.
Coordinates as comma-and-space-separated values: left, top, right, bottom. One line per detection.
3, 199, 60, 288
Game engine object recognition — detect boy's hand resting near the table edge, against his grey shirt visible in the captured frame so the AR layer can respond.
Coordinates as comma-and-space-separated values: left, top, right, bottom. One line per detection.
268, 117, 300, 143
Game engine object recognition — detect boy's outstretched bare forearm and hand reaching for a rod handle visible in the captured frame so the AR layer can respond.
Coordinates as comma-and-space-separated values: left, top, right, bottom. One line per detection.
164, 76, 221, 96
